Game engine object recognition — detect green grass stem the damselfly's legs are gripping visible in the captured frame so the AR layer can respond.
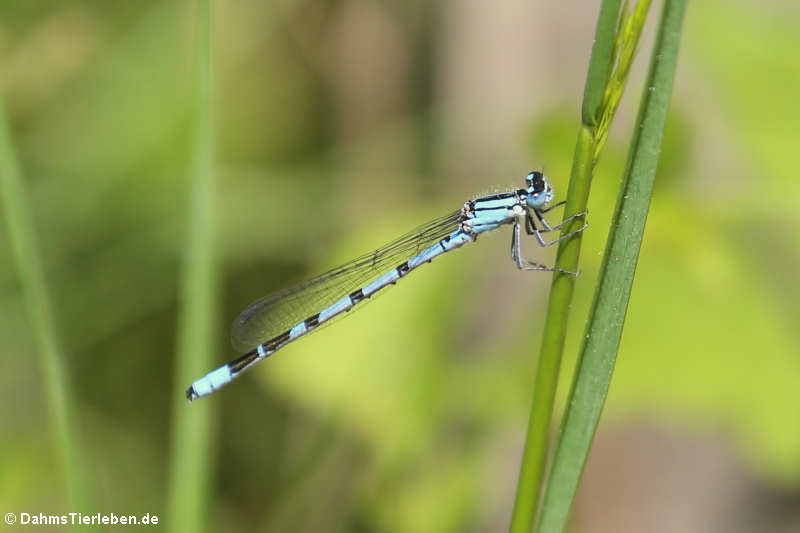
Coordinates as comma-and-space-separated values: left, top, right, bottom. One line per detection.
510, 0, 650, 533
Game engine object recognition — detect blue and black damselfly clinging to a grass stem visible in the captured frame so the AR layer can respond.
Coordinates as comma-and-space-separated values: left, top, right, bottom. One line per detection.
186, 172, 586, 400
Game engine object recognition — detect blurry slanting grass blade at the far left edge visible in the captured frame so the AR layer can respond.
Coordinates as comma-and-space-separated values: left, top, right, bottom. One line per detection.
0, 100, 90, 512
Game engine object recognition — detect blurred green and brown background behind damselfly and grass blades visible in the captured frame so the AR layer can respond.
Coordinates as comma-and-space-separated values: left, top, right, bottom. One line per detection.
0, 0, 800, 532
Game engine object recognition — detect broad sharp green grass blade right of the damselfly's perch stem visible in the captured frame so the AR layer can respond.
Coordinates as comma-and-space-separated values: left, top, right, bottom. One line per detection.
538, 0, 686, 533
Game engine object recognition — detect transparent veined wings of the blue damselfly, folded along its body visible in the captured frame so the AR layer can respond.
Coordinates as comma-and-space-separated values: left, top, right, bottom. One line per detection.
231, 210, 461, 352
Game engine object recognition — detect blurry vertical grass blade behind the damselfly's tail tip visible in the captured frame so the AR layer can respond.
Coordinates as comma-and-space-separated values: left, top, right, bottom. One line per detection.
167, 0, 217, 532
